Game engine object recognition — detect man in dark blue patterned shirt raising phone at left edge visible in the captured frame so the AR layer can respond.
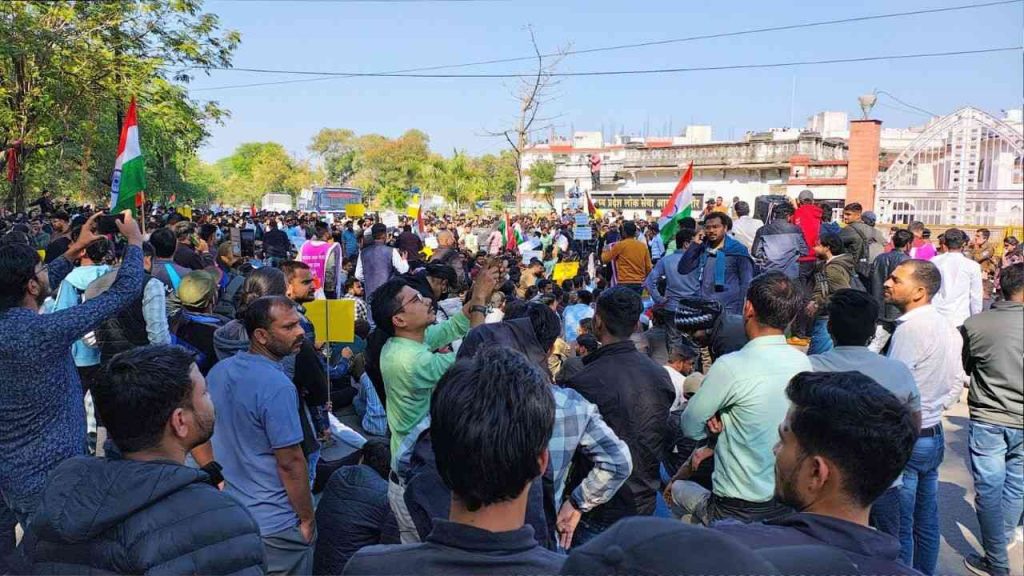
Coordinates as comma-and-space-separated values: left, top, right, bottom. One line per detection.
0, 211, 144, 526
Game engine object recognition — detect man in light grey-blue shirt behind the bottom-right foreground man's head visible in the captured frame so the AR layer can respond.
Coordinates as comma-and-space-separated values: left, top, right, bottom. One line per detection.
809, 288, 921, 538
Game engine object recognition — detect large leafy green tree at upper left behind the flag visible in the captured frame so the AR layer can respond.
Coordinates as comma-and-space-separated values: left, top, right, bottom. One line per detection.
0, 0, 240, 207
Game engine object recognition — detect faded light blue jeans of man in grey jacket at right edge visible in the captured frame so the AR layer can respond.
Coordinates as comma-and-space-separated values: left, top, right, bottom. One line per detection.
970, 420, 1024, 570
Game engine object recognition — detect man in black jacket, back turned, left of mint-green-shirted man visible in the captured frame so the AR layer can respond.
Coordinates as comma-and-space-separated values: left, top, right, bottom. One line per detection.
566, 287, 676, 545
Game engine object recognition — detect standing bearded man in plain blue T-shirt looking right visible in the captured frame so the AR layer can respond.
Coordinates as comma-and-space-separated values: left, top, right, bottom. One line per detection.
207, 296, 315, 574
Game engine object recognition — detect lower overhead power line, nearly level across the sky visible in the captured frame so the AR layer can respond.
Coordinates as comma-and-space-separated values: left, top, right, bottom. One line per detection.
193, 46, 1024, 87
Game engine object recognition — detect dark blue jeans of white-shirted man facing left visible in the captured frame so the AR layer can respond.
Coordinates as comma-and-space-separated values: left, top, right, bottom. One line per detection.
899, 424, 945, 574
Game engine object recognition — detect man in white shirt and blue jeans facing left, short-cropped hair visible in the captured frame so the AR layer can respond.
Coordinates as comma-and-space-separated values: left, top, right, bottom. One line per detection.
883, 259, 967, 574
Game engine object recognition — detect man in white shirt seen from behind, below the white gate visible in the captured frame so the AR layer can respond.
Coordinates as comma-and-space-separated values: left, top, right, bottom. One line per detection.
931, 228, 983, 328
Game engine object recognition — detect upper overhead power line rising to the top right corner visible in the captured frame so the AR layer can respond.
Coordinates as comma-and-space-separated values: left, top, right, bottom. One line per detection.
188, 0, 1024, 90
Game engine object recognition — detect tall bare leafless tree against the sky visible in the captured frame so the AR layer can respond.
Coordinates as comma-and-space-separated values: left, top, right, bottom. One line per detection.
487, 26, 571, 212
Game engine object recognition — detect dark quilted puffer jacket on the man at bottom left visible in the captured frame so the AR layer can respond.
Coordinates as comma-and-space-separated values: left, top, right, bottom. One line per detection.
15, 456, 264, 574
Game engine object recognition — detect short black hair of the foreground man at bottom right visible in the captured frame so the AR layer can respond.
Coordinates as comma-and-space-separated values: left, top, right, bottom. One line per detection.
785, 372, 918, 507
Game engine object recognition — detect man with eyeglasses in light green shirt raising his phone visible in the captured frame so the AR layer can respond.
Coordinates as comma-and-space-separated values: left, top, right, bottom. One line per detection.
371, 264, 500, 543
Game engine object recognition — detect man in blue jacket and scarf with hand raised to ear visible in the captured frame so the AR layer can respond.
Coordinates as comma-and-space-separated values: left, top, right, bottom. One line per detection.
678, 212, 754, 314
